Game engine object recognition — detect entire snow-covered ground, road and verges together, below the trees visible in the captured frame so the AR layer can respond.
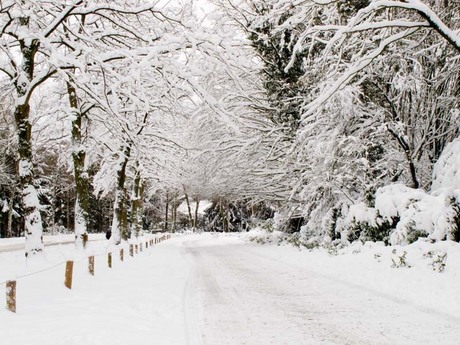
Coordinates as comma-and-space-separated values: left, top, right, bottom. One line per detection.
0, 234, 460, 345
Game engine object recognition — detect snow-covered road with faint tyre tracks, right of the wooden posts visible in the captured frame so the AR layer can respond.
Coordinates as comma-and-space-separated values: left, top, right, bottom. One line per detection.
182, 235, 460, 345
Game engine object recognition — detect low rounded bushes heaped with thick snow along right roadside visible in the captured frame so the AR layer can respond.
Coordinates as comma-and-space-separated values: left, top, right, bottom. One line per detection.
343, 184, 460, 245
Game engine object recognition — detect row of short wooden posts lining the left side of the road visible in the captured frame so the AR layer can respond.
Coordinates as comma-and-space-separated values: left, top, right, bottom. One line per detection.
6, 235, 171, 313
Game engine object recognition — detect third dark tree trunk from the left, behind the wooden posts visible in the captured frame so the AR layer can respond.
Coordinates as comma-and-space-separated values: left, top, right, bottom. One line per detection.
111, 144, 131, 244
